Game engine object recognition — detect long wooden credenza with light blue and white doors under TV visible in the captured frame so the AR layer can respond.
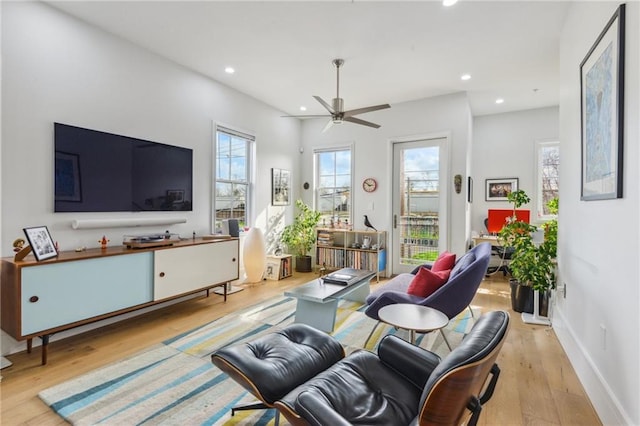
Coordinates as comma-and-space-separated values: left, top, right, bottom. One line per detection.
0, 238, 240, 364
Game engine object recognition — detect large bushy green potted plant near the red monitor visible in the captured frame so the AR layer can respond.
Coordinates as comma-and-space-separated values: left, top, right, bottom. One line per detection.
499, 190, 558, 315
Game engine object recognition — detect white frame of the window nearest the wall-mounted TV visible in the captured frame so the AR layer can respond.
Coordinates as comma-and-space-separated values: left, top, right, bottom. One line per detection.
211, 124, 256, 233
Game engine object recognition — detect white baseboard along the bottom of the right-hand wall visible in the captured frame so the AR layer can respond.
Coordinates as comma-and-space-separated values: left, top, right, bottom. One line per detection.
553, 305, 633, 425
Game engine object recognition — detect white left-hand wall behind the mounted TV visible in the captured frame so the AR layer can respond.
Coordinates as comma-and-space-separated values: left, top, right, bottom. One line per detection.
0, 2, 300, 353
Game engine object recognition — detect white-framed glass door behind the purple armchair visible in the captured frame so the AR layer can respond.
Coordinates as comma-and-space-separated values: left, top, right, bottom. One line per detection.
391, 138, 448, 274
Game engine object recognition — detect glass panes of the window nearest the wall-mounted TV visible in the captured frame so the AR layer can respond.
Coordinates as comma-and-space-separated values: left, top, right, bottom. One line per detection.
213, 126, 255, 230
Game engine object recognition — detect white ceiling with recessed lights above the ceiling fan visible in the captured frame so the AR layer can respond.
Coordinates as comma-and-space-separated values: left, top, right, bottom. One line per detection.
48, 0, 569, 119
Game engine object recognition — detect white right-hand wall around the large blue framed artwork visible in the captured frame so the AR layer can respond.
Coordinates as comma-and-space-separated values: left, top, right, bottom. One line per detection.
554, 1, 640, 425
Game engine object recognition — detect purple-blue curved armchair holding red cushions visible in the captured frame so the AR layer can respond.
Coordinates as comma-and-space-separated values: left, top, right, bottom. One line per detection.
364, 243, 491, 344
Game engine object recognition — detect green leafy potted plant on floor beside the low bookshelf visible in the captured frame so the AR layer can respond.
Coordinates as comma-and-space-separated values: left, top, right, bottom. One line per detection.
280, 200, 320, 272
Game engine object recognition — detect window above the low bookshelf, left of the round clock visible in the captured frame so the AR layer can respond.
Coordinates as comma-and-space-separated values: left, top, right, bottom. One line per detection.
315, 148, 352, 226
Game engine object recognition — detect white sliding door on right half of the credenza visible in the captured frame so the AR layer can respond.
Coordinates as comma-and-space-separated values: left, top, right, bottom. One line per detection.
153, 240, 239, 300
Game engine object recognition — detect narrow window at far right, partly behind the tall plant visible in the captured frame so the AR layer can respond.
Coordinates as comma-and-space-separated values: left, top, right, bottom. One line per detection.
536, 142, 560, 219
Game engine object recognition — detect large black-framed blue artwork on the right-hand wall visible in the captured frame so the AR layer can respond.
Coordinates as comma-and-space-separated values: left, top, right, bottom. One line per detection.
580, 4, 625, 201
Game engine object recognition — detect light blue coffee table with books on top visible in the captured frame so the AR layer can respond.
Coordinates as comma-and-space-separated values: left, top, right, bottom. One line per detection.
284, 268, 376, 333
